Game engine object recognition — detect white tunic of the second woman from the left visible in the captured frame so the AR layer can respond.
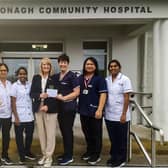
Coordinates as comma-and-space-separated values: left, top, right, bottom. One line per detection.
11, 80, 34, 122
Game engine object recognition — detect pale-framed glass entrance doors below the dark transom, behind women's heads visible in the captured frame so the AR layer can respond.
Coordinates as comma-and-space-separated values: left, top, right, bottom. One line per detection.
1, 52, 61, 82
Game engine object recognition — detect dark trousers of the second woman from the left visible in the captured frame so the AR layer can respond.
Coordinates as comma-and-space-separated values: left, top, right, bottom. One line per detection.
15, 121, 34, 159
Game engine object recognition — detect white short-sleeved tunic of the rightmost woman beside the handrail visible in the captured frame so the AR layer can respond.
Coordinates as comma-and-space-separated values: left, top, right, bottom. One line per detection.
105, 73, 132, 121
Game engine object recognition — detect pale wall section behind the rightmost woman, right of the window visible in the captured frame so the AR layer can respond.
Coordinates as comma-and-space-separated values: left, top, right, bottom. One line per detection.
112, 38, 138, 91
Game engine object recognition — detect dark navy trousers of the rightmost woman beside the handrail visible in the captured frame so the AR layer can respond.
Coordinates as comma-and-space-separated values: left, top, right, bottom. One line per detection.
105, 120, 129, 162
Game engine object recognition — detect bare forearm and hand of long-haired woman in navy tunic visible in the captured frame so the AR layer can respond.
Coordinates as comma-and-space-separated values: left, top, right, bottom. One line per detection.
95, 93, 107, 119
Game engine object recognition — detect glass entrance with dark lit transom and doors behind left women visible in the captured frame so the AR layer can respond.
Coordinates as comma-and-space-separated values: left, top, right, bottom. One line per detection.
0, 42, 63, 82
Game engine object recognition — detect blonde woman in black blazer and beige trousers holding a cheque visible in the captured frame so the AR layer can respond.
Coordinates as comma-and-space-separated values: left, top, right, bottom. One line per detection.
30, 58, 57, 167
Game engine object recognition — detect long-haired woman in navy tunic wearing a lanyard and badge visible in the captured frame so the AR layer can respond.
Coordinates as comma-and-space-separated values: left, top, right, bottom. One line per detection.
79, 57, 107, 165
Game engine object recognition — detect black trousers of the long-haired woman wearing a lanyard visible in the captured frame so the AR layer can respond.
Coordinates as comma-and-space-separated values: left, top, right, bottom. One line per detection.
80, 115, 102, 157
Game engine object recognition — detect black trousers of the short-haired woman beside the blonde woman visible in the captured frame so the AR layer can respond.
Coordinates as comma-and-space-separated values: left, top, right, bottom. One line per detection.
57, 111, 75, 158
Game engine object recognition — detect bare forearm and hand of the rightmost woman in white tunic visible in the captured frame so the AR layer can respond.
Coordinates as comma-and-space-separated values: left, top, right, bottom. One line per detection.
120, 93, 129, 123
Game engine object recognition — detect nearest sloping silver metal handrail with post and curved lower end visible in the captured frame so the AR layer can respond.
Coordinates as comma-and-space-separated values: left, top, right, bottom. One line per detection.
130, 100, 164, 167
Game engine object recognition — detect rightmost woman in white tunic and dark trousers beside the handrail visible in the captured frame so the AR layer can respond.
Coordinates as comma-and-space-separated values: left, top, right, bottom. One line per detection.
105, 60, 132, 166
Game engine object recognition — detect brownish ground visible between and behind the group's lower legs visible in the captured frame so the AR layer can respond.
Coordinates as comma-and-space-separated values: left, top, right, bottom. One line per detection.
1, 137, 168, 168
